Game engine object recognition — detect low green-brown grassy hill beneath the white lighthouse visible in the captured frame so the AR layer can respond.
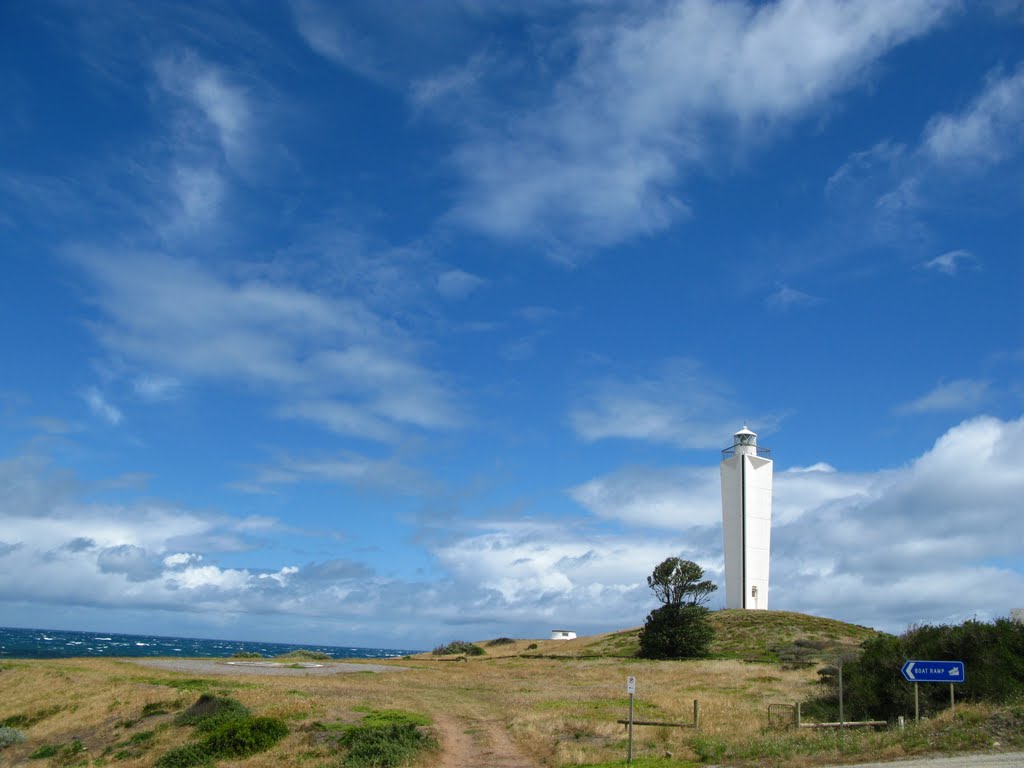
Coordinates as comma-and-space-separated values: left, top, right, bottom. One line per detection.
425, 610, 880, 663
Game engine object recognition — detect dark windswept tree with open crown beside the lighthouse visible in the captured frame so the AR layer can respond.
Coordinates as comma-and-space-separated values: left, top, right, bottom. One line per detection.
639, 557, 718, 658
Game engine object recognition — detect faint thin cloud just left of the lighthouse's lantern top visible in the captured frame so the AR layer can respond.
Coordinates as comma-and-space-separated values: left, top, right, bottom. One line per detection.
569, 358, 764, 449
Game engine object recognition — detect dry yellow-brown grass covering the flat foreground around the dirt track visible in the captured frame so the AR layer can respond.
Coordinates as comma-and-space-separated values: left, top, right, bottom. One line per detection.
0, 639, 1024, 768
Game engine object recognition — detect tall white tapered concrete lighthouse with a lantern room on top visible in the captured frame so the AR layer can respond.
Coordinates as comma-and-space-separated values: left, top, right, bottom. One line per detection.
721, 424, 772, 610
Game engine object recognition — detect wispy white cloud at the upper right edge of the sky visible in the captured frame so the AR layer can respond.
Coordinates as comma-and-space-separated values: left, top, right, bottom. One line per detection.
924, 65, 1024, 167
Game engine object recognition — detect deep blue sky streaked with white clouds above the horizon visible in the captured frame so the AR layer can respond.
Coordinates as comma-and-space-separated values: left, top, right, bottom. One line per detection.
0, 0, 1024, 648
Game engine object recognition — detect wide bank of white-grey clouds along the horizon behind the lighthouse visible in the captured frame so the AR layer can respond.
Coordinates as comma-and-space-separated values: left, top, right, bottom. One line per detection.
0, 418, 1024, 647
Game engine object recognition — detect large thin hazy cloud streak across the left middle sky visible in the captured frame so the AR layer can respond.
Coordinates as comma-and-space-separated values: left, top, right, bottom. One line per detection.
70, 248, 462, 439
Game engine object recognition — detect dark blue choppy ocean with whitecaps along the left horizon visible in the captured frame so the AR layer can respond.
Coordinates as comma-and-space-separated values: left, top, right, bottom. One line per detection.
0, 627, 420, 658
